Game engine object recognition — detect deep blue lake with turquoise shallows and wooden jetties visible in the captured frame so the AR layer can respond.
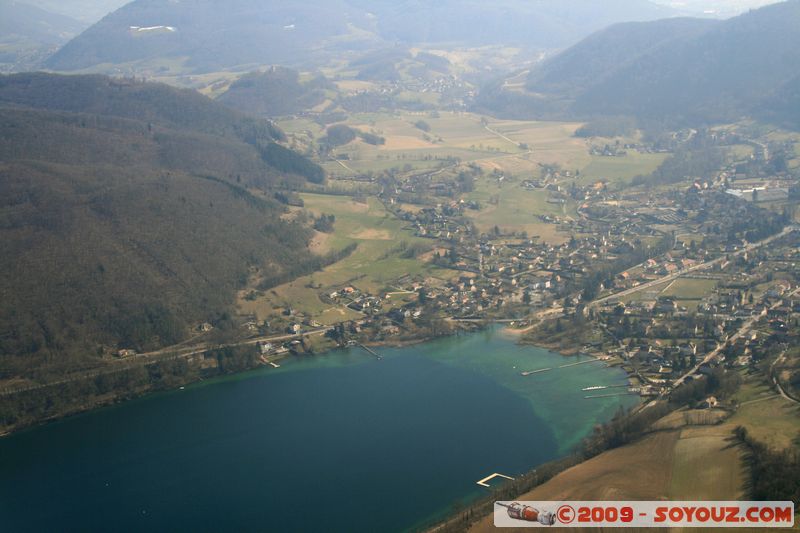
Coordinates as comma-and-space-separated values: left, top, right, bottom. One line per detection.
0, 329, 638, 531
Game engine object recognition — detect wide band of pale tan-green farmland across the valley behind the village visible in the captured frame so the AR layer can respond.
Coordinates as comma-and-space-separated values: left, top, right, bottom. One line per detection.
279, 112, 665, 181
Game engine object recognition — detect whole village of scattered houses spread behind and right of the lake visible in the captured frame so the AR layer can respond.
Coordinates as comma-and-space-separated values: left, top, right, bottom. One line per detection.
239, 133, 800, 404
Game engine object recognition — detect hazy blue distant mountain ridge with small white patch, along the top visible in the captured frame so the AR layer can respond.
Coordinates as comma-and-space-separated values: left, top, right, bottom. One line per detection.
47, 0, 673, 72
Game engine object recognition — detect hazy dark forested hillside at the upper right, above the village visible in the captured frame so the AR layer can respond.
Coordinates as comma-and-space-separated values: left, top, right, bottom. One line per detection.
479, 0, 800, 127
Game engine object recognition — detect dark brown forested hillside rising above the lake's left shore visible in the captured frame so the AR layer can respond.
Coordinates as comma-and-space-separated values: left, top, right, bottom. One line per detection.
0, 75, 321, 377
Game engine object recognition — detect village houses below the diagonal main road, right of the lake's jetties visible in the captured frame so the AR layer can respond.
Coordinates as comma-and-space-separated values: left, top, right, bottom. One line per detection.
594, 232, 800, 395
